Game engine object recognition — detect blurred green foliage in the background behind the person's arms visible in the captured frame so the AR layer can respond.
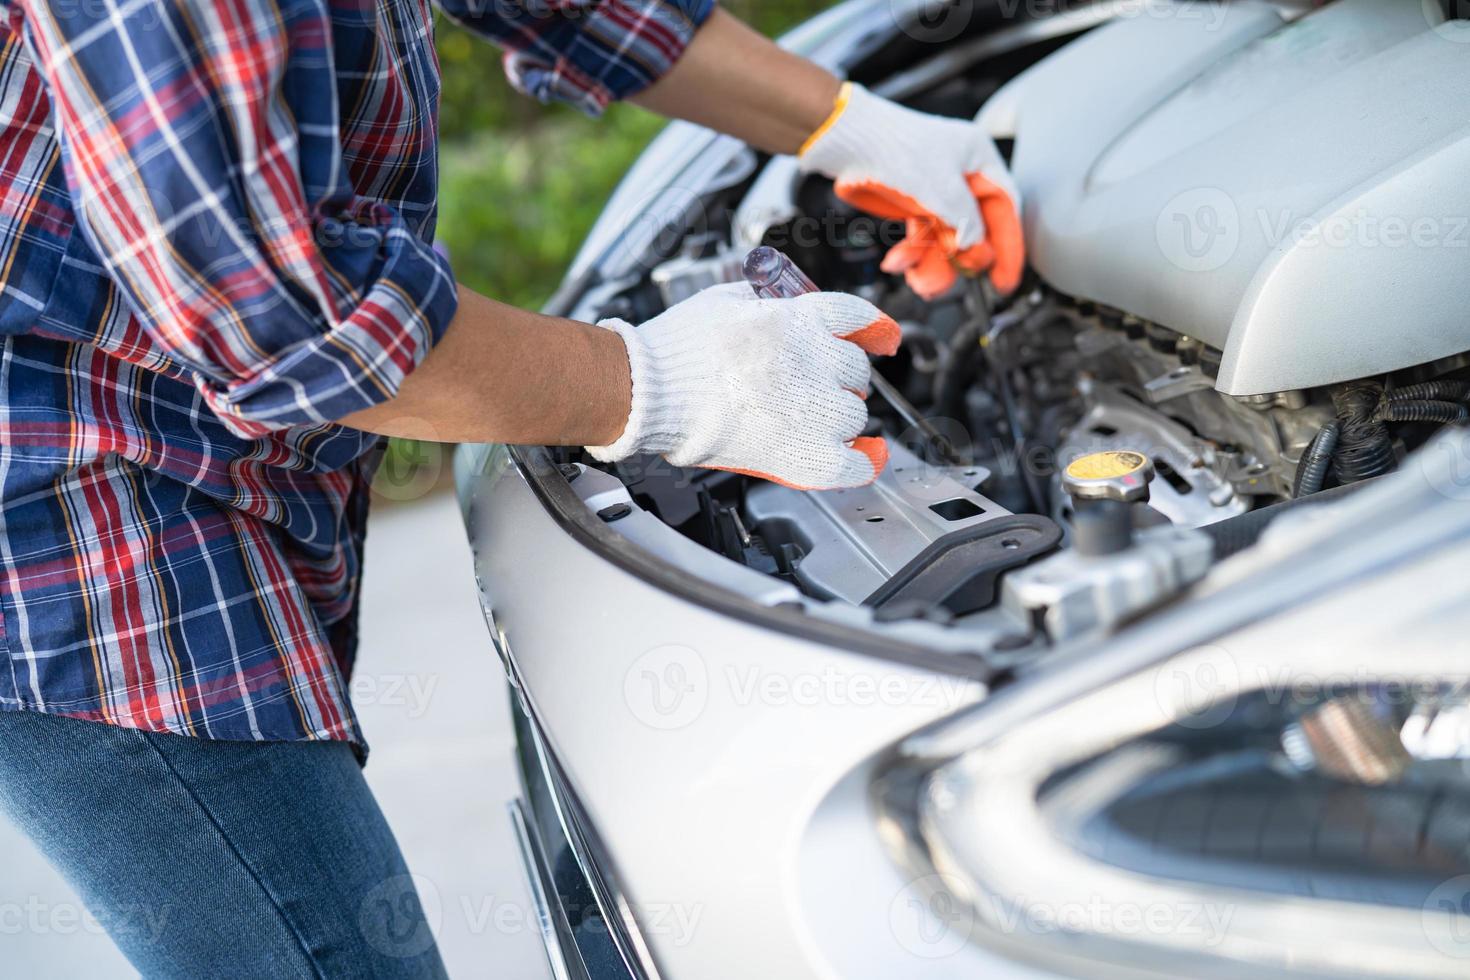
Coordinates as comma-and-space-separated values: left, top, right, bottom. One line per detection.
437, 0, 831, 309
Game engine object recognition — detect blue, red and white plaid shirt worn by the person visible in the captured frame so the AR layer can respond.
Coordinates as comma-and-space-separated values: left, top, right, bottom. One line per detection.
0, 0, 713, 745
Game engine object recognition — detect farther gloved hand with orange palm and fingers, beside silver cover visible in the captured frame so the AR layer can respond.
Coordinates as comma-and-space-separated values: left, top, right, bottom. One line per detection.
797, 82, 1026, 300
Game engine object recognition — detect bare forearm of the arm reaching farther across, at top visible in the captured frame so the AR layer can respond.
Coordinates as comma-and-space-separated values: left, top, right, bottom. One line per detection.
632, 9, 841, 153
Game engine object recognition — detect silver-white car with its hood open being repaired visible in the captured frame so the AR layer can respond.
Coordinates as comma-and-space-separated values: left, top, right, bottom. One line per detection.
456, 0, 1470, 980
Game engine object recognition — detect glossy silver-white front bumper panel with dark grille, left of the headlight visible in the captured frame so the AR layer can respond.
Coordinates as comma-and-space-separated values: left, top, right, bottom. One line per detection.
457, 447, 983, 979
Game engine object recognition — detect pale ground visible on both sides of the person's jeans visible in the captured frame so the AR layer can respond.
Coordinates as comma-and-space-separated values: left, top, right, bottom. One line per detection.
0, 492, 547, 980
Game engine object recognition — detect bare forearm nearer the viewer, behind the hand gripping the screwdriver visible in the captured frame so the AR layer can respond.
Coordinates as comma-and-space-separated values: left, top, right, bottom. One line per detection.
338, 287, 632, 445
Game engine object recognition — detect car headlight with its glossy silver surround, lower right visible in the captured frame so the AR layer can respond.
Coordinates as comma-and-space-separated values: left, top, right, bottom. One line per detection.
879, 433, 1470, 977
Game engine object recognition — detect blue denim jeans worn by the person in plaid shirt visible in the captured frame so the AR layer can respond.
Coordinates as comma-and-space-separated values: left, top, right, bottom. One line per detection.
0, 711, 444, 979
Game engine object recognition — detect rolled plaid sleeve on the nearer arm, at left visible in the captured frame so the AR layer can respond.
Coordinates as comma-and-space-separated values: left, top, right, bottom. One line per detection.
16, 0, 457, 438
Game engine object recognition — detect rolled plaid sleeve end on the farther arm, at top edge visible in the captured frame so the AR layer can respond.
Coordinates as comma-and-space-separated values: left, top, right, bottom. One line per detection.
437, 0, 714, 116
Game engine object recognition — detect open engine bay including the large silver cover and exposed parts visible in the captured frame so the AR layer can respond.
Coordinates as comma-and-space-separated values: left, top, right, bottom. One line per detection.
552, 0, 1470, 652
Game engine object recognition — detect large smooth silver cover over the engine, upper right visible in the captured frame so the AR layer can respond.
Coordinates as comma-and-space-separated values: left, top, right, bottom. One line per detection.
980, 0, 1470, 395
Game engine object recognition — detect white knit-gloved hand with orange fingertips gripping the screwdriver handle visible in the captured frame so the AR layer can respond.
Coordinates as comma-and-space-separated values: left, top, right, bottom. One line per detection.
588, 282, 898, 489
